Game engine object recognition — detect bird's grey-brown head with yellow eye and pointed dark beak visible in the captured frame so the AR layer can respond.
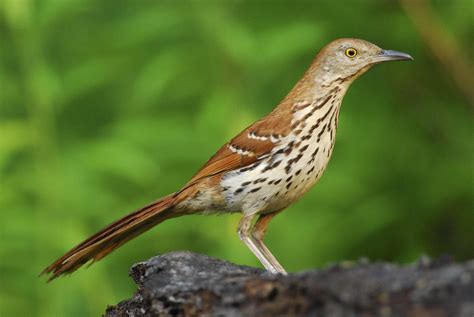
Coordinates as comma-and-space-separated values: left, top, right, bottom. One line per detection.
312, 38, 413, 86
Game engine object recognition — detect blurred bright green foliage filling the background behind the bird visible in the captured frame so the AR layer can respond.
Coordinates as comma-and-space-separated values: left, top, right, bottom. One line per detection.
0, 0, 474, 316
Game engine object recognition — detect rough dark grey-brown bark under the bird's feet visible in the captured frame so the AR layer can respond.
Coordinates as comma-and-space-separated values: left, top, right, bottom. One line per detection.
105, 252, 474, 317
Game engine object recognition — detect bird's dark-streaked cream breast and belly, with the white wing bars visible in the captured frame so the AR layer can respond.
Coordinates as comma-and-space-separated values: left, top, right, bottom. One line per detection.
220, 86, 345, 214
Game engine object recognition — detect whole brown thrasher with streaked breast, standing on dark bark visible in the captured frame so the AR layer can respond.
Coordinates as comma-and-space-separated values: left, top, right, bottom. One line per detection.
43, 39, 412, 279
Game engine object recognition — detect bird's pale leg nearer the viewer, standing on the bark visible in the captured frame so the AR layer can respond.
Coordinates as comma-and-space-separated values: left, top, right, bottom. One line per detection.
237, 215, 286, 274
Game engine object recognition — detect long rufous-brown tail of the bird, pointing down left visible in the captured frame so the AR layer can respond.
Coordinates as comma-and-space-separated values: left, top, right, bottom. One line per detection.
41, 195, 178, 281
